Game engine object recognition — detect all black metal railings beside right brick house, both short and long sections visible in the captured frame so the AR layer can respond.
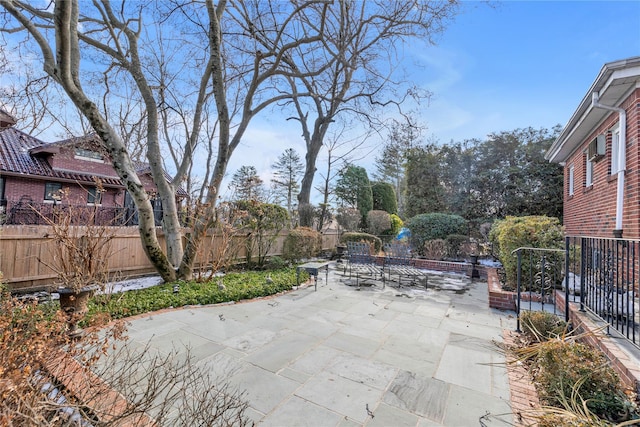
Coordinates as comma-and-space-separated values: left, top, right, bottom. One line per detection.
514, 236, 640, 346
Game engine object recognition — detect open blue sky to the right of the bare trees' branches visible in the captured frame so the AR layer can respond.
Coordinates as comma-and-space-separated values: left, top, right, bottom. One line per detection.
228, 1, 640, 199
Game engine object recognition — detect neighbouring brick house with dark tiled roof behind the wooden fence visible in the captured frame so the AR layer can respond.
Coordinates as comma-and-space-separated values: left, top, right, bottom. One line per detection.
0, 110, 180, 225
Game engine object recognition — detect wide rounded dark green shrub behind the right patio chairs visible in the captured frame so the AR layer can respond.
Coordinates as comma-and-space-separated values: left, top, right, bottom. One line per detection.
405, 213, 467, 255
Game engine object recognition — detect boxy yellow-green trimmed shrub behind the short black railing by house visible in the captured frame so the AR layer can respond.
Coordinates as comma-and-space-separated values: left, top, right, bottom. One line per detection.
489, 216, 563, 289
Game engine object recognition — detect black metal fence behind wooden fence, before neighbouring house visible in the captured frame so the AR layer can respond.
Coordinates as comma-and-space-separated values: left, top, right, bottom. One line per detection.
0, 200, 162, 227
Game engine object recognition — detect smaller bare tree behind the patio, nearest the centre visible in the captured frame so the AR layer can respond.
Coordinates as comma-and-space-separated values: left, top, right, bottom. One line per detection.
272, 0, 458, 217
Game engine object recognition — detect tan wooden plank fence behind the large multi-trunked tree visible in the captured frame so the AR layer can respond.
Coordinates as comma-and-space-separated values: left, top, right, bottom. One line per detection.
0, 225, 338, 291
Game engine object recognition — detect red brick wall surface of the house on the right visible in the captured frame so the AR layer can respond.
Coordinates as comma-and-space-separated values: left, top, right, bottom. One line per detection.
564, 89, 640, 238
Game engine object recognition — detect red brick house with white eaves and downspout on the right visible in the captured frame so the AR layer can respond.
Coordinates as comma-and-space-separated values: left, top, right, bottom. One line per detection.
546, 57, 640, 239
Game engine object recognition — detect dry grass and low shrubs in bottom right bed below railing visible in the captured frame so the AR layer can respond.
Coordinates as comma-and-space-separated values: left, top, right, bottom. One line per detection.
505, 314, 640, 427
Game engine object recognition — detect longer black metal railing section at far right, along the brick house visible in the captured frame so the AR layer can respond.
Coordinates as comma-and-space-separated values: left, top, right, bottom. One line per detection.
565, 236, 640, 346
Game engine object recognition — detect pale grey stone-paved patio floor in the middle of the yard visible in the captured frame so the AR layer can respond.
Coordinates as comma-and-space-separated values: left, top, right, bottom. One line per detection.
129, 269, 515, 427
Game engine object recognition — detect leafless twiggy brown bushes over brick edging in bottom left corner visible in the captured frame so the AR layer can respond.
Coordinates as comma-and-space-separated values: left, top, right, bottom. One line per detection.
0, 293, 250, 426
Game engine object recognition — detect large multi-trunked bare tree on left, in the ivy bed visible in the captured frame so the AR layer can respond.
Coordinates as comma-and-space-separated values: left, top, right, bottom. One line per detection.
0, 0, 328, 280
